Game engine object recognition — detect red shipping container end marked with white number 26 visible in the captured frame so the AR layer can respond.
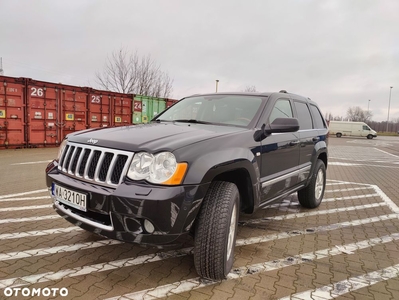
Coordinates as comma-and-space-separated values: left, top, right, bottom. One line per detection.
25, 79, 62, 147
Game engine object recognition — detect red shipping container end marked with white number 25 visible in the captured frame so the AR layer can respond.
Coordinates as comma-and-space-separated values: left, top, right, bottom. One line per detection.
87, 88, 112, 128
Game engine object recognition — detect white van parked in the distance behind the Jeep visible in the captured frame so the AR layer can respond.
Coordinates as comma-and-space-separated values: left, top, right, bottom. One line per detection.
328, 121, 377, 139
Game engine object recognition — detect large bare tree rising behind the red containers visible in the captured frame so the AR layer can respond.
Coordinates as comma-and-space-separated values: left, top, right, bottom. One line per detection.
96, 49, 173, 98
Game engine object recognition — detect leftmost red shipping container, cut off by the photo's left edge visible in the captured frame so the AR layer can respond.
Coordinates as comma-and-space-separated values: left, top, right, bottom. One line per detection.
0, 76, 26, 149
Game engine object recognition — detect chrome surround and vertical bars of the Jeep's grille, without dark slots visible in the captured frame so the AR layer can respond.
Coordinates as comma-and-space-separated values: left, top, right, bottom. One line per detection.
58, 142, 134, 188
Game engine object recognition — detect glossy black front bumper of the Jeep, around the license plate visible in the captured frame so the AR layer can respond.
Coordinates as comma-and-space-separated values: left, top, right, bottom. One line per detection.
46, 161, 208, 246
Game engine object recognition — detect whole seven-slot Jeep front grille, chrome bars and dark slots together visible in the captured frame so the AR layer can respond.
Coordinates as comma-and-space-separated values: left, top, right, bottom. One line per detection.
58, 142, 134, 187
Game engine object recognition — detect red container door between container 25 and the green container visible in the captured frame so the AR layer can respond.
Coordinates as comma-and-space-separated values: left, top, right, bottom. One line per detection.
110, 92, 133, 126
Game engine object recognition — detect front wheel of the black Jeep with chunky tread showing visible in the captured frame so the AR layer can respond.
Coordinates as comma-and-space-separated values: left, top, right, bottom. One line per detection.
194, 181, 240, 280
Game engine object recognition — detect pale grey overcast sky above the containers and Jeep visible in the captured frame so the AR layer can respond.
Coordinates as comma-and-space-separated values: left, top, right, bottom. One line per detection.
0, 0, 399, 121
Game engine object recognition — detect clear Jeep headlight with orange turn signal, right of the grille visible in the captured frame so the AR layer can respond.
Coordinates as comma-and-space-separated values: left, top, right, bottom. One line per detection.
127, 152, 187, 185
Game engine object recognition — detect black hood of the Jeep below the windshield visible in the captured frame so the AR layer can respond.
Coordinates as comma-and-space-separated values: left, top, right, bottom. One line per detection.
68, 122, 247, 153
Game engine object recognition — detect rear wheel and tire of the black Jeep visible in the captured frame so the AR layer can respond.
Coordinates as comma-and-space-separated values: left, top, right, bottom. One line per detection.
298, 159, 326, 208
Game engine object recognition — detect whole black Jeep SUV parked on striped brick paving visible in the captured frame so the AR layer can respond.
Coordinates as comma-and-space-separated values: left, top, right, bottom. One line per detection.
46, 91, 328, 279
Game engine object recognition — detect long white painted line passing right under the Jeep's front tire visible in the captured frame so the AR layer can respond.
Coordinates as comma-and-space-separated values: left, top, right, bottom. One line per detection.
106, 233, 399, 300
